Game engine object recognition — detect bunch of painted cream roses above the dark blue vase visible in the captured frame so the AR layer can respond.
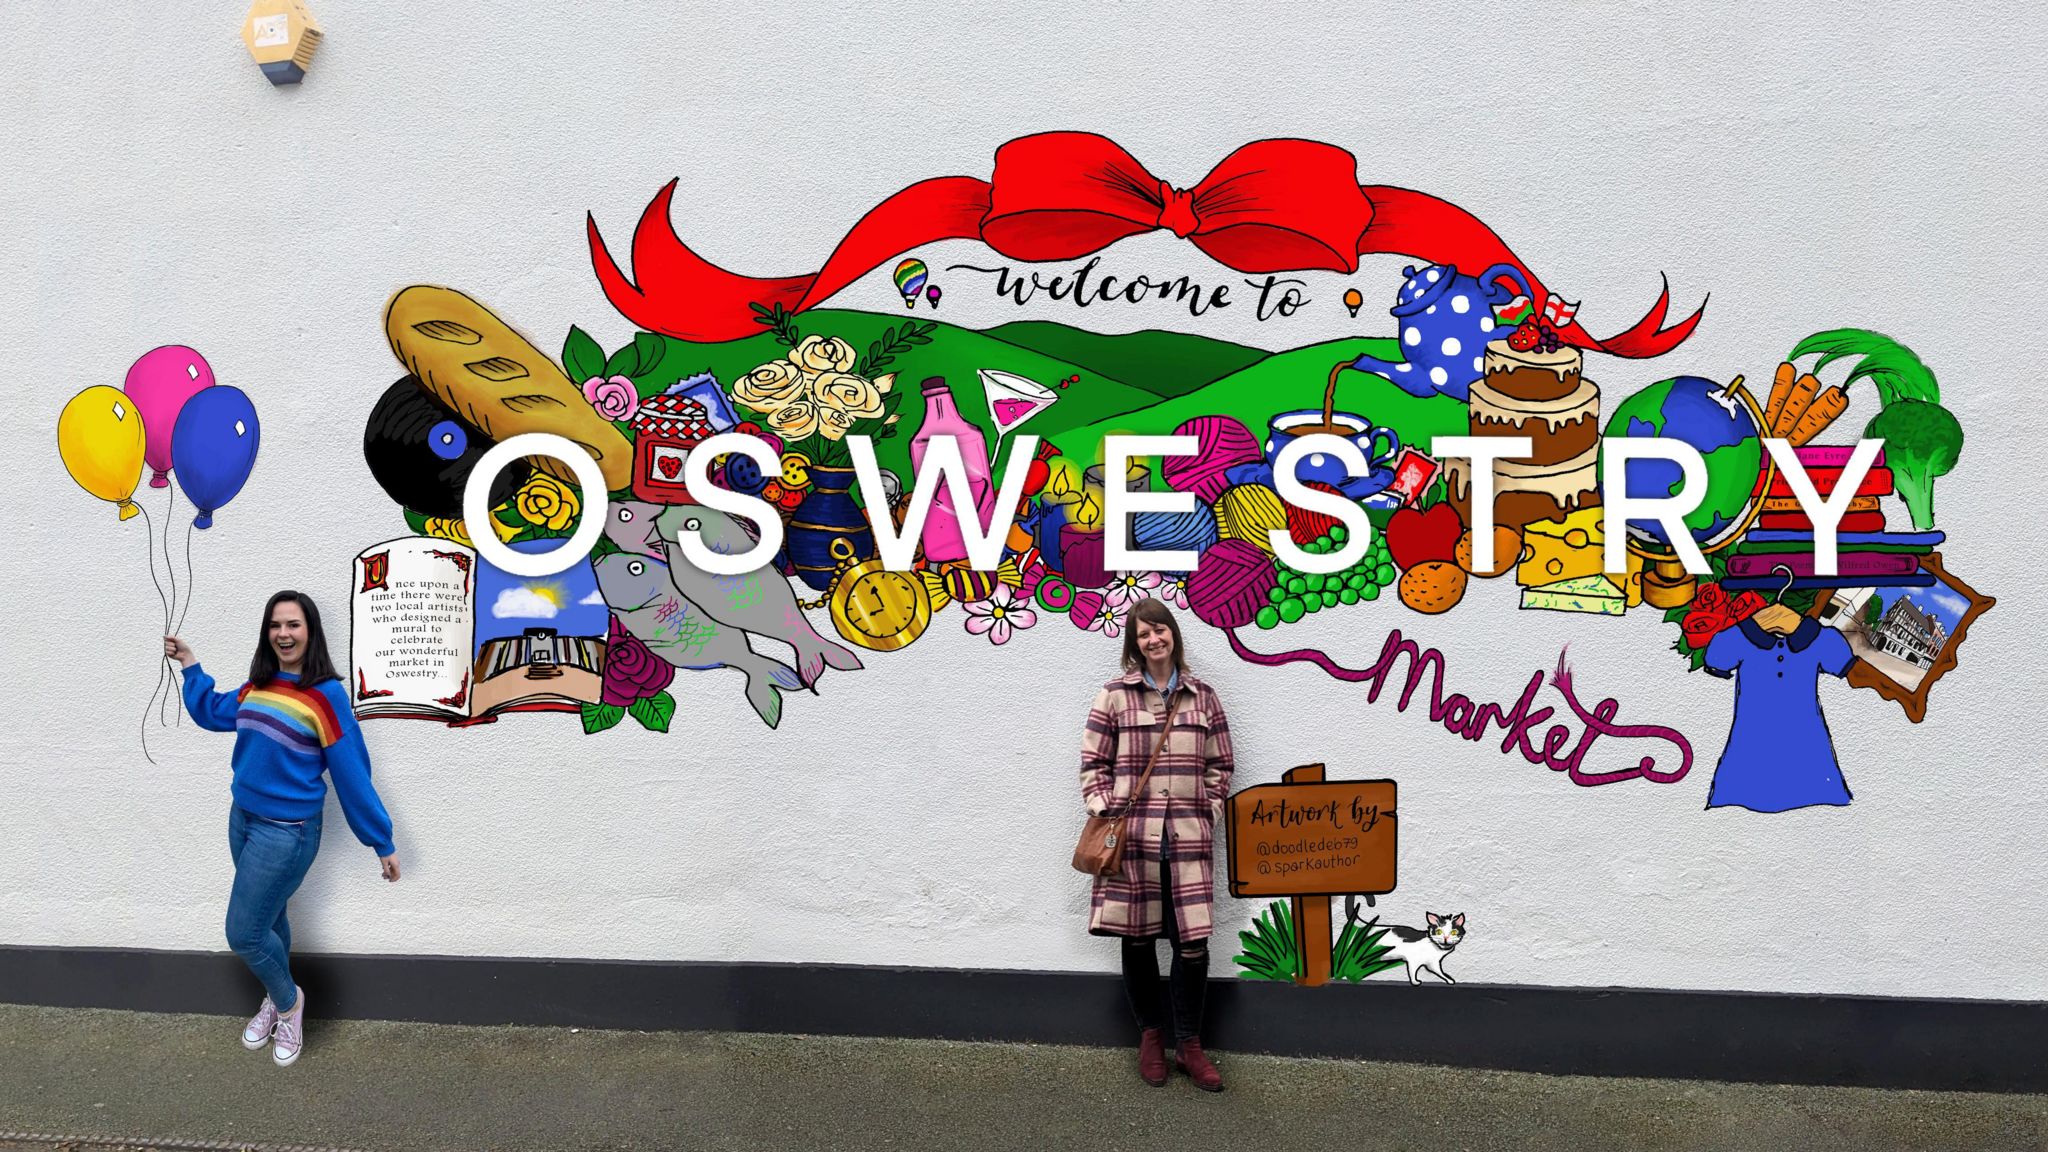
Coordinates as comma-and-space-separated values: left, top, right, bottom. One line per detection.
731, 336, 903, 465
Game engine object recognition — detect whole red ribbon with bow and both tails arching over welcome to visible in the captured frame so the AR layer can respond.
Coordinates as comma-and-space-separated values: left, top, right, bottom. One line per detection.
586, 131, 1704, 357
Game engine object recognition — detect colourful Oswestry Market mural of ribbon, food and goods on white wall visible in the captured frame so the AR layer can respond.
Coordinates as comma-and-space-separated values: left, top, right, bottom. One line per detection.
323, 133, 1991, 815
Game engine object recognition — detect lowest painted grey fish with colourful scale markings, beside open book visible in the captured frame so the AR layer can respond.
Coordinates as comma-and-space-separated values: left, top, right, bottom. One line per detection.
596, 553, 803, 728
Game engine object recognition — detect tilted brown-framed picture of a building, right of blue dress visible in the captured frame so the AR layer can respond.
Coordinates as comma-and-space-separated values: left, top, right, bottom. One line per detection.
1806, 553, 1997, 724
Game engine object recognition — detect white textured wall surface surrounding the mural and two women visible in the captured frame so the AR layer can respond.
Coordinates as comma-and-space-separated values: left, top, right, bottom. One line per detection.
0, 0, 2048, 998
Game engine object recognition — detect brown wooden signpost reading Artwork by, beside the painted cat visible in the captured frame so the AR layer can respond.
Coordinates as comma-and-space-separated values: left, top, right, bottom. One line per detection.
1227, 765, 1395, 986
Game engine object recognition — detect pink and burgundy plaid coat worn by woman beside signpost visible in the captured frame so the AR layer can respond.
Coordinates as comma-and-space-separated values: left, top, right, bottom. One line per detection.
1081, 672, 1235, 941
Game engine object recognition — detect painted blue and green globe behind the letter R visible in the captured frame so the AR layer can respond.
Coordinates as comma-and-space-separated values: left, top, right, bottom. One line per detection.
1599, 375, 1763, 551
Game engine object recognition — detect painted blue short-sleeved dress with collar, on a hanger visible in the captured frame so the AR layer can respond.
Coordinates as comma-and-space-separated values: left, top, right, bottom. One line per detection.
1706, 619, 1855, 812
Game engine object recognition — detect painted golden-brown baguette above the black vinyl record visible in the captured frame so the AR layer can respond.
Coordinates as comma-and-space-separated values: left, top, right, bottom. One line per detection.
385, 285, 633, 487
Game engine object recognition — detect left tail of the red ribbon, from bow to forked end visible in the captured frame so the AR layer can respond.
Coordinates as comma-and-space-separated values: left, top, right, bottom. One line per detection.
586, 176, 989, 342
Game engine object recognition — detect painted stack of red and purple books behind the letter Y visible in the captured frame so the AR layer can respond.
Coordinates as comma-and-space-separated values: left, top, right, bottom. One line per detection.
1720, 445, 1944, 592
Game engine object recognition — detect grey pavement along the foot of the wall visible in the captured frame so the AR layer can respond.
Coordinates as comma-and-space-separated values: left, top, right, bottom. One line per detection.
0, 1006, 2048, 1152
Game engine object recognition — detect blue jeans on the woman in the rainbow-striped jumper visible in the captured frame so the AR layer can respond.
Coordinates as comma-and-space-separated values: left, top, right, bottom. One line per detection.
227, 806, 319, 1013
